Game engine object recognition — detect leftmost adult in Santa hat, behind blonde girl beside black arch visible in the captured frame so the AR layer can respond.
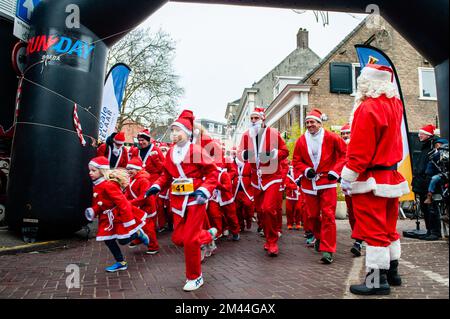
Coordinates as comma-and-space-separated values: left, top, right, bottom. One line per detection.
97, 132, 128, 168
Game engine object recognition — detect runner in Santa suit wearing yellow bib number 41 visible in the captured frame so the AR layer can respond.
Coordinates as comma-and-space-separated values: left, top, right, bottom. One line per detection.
147, 110, 219, 291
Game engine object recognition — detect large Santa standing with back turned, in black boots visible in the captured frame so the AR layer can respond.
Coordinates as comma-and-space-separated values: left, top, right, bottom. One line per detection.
341, 64, 410, 295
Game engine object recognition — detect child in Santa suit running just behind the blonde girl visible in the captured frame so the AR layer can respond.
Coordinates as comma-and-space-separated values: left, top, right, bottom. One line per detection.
125, 157, 159, 255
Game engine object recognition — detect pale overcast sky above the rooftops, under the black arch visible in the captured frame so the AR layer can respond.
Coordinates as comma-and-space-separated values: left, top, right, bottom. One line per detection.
144, 2, 365, 121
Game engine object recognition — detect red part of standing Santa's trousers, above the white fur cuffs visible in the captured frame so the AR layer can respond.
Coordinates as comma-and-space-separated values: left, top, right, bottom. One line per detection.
352, 192, 400, 247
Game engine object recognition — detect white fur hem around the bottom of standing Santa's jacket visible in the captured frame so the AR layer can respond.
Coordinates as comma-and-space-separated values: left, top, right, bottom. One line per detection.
352, 177, 410, 198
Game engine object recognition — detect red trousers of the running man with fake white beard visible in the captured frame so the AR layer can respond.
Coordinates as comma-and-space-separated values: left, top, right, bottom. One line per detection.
255, 183, 283, 250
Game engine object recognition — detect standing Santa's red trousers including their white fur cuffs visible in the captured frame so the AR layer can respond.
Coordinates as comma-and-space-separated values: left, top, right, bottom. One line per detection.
352, 193, 401, 269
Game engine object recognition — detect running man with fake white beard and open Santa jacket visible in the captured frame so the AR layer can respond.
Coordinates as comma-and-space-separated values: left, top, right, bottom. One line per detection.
238, 108, 289, 257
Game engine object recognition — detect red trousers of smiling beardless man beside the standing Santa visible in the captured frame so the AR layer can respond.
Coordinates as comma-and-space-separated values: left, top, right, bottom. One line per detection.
304, 188, 337, 253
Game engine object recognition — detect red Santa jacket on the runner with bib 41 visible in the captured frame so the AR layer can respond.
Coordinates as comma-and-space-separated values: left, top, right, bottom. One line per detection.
153, 143, 219, 217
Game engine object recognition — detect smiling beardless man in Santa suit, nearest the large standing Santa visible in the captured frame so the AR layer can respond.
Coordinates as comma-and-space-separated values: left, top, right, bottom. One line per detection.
293, 109, 345, 264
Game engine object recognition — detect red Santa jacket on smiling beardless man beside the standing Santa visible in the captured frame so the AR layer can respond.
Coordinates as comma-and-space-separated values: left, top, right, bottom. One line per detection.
292, 128, 346, 195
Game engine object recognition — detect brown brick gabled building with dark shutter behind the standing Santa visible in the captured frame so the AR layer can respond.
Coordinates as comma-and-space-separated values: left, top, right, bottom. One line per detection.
267, 18, 438, 134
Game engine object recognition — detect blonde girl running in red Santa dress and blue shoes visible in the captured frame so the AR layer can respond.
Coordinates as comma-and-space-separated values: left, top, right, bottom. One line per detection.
85, 156, 149, 272
